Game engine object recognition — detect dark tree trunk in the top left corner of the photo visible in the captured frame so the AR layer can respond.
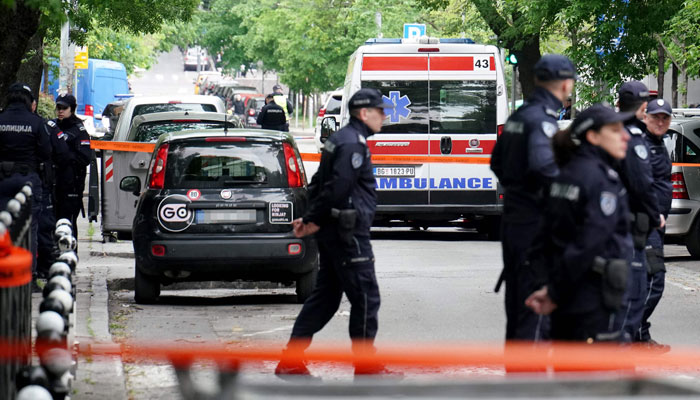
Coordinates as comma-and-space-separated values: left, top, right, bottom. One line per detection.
0, 0, 41, 106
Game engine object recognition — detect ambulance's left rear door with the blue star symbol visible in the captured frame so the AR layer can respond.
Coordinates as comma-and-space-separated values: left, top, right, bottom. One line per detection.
361, 54, 431, 219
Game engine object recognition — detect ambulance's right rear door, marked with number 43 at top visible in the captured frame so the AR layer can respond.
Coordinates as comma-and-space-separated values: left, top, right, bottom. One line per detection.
428, 49, 507, 219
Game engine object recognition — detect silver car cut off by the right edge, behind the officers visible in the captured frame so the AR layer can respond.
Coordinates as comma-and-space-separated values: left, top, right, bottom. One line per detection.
665, 118, 700, 258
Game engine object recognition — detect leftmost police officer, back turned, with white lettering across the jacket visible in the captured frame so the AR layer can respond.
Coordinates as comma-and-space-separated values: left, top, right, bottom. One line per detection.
0, 83, 51, 276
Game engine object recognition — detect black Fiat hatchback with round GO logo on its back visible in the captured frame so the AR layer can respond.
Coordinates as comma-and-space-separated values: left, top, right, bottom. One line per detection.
120, 129, 318, 304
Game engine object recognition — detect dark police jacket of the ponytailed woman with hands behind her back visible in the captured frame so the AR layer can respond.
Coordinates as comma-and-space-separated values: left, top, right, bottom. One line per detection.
530, 142, 632, 312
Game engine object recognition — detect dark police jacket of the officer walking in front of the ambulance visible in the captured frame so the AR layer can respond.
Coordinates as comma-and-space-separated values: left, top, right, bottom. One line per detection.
304, 117, 377, 240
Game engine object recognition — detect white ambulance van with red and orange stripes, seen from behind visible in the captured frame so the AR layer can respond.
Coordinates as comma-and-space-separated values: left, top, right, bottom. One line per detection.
341, 37, 508, 236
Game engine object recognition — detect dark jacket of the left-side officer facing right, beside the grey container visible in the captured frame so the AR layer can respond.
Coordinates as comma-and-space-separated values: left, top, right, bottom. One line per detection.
54, 115, 94, 191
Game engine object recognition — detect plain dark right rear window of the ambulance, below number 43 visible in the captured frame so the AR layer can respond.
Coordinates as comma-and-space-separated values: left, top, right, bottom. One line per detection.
430, 80, 497, 134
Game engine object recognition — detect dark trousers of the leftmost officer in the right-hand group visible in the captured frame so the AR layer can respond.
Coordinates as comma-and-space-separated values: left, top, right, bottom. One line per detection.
501, 219, 550, 340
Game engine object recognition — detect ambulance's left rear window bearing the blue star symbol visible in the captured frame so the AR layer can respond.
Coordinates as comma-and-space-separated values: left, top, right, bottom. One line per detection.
362, 81, 430, 134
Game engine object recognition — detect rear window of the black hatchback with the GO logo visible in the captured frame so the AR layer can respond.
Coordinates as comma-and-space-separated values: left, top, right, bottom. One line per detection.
165, 141, 286, 189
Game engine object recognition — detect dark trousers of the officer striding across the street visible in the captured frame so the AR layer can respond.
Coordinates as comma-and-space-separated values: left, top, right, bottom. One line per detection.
291, 237, 380, 349
